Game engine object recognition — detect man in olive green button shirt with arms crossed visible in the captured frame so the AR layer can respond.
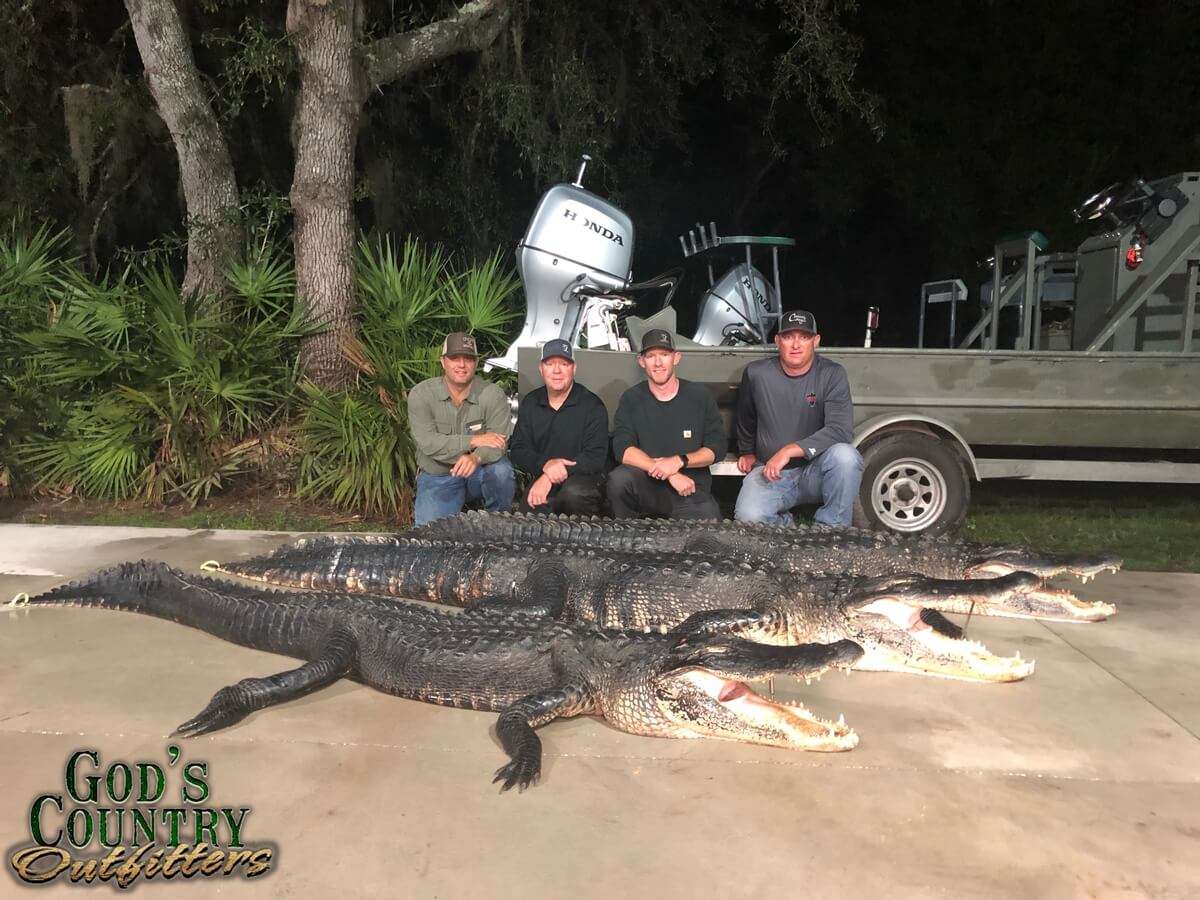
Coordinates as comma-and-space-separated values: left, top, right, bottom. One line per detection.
408, 331, 516, 526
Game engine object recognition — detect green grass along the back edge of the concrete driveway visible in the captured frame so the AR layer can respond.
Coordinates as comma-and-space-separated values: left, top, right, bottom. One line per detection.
0, 479, 1200, 572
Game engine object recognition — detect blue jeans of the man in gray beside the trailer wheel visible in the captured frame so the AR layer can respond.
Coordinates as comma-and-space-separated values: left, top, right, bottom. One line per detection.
733, 444, 863, 526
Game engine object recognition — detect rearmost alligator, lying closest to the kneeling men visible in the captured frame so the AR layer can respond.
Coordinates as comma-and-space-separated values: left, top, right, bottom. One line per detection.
413, 511, 1122, 582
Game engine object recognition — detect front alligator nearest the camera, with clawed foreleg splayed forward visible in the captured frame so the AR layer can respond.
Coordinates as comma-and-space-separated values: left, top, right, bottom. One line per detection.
13, 560, 862, 790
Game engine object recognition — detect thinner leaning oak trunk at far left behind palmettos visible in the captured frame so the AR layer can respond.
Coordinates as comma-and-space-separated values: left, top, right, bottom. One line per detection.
125, 0, 241, 303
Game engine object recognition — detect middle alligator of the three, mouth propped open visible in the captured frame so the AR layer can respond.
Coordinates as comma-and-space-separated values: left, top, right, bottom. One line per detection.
220, 538, 1043, 682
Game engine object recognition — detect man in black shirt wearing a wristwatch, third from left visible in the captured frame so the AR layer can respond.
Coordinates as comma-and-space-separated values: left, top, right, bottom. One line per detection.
608, 329, 726, 518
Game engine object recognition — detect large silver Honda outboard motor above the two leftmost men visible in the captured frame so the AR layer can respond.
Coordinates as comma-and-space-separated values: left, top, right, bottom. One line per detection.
490, 156, 634, 371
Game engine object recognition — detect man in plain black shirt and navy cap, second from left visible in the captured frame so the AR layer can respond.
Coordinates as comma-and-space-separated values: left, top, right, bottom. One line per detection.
509, 340, 608, 516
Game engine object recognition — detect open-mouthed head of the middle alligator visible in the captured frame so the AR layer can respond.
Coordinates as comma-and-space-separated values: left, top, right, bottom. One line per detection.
841, 572, 1040, 682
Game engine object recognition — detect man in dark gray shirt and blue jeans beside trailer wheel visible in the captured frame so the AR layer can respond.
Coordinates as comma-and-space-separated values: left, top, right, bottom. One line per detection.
733, 310, 863, 526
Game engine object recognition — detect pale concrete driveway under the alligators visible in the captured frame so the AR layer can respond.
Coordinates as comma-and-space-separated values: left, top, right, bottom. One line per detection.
0, 526, 1200, 898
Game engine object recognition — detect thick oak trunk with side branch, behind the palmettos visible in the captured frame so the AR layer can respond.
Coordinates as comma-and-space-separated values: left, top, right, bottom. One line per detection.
287, 0, 509, 388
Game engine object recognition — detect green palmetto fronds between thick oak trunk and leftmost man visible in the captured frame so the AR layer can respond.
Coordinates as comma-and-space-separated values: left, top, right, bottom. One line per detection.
299, 239, 517, 520
